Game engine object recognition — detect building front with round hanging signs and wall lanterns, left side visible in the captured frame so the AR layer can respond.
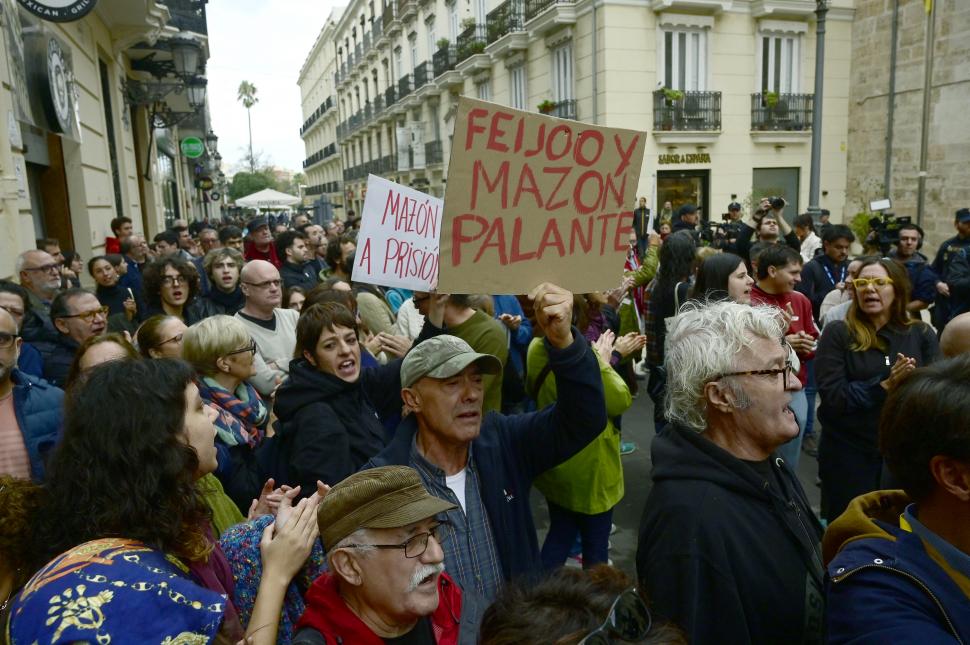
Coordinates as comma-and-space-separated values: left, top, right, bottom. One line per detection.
0, 0, 215, 279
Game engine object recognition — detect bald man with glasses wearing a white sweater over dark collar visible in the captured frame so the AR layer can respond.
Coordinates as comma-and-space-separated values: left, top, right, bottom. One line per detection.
236, 260, 300, 396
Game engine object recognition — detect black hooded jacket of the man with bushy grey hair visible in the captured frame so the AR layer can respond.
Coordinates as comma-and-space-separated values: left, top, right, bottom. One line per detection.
637, 425, 824, 644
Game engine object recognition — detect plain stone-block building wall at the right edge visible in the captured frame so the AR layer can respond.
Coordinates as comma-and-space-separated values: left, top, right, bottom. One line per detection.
847, 0, 970, 253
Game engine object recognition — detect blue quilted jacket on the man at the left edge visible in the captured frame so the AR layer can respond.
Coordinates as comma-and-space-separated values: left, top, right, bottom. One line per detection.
12, 369, 64, 482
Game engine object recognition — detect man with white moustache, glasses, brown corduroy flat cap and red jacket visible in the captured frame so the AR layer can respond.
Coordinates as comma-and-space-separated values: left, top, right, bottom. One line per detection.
293, 466, 485, 645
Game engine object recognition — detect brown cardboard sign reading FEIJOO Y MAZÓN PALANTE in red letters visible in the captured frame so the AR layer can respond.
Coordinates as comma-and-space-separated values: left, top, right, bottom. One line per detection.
438, 97, 646, 293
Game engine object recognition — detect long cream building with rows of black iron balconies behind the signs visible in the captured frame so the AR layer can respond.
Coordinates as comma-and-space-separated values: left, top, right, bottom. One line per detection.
301, 0, 854, 220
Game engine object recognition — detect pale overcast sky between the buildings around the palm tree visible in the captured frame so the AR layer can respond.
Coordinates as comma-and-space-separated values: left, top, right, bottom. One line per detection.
206, 0, 336, 171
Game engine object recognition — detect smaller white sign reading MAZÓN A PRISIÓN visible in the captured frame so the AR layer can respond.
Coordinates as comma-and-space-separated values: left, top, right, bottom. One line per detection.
351, 175, 444, 291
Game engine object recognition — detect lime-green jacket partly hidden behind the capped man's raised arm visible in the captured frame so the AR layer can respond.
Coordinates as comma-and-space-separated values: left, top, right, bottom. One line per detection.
526, 338, 633, 515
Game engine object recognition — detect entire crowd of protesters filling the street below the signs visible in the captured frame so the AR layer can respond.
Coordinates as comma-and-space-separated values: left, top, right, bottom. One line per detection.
0, 198, 970, 645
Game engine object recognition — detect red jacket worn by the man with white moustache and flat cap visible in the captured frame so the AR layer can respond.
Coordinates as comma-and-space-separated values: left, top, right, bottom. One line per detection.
296, 573, 462, 645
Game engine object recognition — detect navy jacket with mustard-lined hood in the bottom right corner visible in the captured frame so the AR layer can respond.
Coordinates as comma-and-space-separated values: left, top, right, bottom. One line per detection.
823, 490, 970, 643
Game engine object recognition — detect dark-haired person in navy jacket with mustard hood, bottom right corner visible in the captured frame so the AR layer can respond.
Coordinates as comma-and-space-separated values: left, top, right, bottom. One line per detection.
824, 354, 970, 643
